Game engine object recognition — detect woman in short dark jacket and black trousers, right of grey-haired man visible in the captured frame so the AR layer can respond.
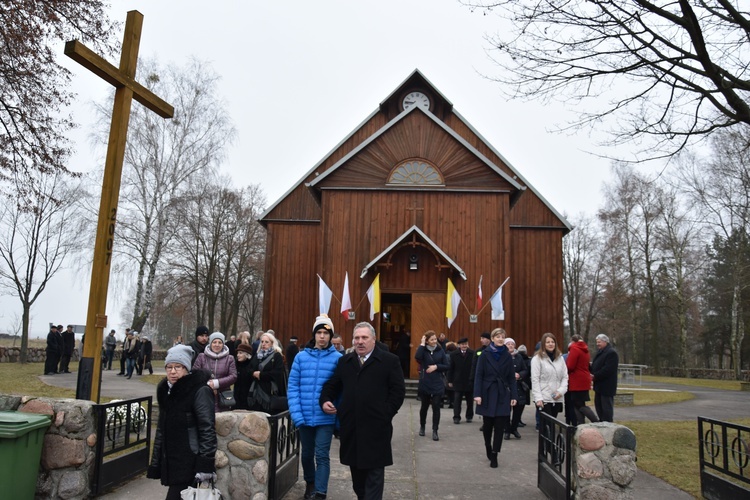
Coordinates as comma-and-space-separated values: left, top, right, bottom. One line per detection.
414, 330, 450, 441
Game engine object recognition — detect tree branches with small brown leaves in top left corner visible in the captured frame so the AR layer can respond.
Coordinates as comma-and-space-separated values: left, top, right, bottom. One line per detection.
0, 0, 116, 199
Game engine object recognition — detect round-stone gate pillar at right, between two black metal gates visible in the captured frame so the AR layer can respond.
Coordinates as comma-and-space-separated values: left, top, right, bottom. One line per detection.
571, 422, 638, 500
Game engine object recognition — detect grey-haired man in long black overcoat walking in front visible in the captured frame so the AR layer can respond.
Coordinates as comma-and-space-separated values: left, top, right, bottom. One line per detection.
319, 322, 406, 500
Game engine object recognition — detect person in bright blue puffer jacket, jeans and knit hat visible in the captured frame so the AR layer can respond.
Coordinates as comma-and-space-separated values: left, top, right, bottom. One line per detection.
287, 314, 341, 499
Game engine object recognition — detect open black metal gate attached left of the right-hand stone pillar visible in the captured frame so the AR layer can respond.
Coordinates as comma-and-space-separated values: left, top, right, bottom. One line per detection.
537, 412, 575, 500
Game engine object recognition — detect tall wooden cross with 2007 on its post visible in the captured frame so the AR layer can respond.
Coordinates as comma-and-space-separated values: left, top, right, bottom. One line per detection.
65, 10, 174, 402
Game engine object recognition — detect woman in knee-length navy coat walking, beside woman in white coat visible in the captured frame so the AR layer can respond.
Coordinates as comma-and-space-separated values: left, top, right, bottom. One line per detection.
474, 329, 518, 468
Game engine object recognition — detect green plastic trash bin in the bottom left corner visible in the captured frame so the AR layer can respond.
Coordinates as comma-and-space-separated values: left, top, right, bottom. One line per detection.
0, 411, 52, 500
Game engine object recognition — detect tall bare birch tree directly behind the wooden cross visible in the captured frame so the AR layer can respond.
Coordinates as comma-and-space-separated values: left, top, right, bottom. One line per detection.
93, 60, 235, 331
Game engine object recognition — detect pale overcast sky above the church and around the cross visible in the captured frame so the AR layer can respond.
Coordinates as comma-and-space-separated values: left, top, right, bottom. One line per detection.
0, 0, 624, 336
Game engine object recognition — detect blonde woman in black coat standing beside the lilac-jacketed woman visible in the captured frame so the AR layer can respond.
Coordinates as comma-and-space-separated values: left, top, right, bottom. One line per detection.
248, 332, 286, 413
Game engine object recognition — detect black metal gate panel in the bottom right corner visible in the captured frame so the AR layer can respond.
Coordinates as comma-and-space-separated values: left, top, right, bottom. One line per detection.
698, 417, 750, 500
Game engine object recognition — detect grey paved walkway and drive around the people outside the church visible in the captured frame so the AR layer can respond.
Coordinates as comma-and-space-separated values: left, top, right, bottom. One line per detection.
41, 370, 750, 500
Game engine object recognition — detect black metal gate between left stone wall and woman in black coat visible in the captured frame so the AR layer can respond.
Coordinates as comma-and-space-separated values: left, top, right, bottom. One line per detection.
91, 396, 152, 496
